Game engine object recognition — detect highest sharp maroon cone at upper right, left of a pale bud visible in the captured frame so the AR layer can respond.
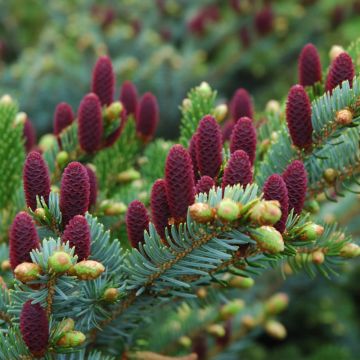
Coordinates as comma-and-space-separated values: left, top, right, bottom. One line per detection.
298, 44, 321, 86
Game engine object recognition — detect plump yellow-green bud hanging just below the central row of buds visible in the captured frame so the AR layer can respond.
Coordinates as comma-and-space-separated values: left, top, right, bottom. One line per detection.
251, 226, 285, 254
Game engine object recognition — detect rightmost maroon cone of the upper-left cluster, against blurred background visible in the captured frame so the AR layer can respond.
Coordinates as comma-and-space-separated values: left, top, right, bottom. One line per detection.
136, 92, 159, 142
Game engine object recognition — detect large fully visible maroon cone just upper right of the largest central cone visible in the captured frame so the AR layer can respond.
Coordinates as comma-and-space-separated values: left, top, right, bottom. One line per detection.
196, 115, 222, 178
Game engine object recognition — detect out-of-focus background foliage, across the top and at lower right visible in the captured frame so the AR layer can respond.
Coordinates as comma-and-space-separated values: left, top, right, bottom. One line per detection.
0, 0, 360, 360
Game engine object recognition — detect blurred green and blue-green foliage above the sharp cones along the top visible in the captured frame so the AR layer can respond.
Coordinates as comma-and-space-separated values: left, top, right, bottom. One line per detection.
0, 0, 360, 137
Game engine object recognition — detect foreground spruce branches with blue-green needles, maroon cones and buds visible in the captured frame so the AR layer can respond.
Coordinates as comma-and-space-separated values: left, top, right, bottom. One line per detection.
0, 39, 360, 360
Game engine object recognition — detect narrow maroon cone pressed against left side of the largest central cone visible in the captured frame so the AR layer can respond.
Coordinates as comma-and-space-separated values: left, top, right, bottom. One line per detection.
150, 179, 171, 239
